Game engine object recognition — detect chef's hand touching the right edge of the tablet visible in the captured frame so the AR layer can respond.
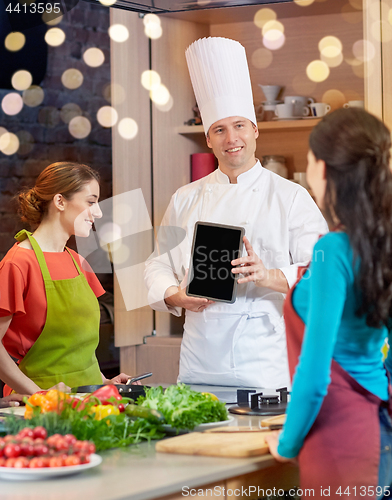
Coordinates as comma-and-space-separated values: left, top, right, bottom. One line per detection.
231, 236, 289, 293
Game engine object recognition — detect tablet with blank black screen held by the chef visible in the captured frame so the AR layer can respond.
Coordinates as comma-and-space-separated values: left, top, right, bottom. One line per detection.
186, 222, 245, 304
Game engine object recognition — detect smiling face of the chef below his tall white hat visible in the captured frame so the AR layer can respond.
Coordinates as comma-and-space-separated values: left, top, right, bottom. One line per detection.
207, 116, 259, 181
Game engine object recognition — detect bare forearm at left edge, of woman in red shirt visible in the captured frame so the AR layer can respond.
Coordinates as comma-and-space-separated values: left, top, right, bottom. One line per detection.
0, 316, 41, 394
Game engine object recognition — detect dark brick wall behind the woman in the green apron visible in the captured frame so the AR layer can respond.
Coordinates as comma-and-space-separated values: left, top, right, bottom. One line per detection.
0, 1, 113, 291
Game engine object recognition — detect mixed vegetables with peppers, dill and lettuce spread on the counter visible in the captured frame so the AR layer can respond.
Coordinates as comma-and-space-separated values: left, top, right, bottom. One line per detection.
0, 384, 227, 458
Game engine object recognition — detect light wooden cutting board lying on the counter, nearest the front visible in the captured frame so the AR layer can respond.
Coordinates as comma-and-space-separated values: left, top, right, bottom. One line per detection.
155, 431, 271, 457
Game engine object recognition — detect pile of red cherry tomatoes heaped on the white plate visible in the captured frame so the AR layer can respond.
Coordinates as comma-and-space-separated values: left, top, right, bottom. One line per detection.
0, 427, 95, 469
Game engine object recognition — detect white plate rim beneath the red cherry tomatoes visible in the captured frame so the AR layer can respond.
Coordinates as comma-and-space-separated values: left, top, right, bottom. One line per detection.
0, 453, 102, 481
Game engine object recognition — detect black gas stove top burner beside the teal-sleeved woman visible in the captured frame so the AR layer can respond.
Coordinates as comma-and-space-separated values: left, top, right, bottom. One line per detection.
229, 387, 290, 416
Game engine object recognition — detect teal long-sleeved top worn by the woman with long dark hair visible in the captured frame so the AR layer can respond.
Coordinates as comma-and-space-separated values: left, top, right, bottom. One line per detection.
278, 232, 392, 458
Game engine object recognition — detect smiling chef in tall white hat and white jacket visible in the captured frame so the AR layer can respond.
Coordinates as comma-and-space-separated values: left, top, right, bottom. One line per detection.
145, 37, 327, 388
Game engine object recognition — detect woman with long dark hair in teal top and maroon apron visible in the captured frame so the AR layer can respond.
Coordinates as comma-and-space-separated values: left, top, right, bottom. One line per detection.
267, 108, 392, 499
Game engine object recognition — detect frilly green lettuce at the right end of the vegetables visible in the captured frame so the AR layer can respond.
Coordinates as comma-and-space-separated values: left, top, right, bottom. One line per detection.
137, 384, 227, 430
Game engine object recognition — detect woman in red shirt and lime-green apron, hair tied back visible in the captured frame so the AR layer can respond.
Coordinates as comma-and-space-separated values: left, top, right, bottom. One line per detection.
0, 162, 128, 394
